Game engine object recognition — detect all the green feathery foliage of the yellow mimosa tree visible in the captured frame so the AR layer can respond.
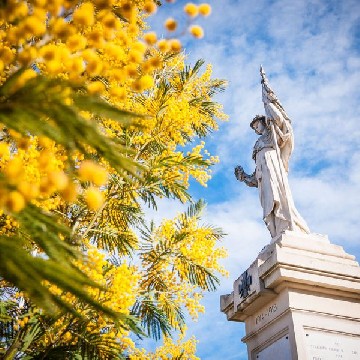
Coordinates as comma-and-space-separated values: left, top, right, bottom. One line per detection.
0, 56, 224, 359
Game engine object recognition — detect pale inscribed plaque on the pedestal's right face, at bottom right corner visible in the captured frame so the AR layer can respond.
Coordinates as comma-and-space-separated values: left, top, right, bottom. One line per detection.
305, 329, 360, 360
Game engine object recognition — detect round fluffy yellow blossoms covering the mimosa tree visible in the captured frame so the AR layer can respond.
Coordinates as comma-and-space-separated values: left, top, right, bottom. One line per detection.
0, 0, 227, 360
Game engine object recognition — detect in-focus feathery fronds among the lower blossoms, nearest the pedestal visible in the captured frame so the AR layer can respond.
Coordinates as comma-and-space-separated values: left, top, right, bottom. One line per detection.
132, 200, 224, 338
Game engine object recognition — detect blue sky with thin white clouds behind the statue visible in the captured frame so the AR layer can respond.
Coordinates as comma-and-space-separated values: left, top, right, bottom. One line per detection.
146, 0, 360, 360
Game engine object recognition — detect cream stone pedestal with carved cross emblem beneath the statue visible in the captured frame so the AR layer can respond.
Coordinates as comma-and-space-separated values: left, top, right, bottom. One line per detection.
220, 232, 360, 360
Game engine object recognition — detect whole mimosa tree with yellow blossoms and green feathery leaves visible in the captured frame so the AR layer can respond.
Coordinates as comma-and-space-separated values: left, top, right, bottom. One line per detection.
0, 0, 226, 359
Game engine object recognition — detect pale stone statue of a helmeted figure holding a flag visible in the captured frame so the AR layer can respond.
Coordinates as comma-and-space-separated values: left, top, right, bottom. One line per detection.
235, 67, 310, 238
